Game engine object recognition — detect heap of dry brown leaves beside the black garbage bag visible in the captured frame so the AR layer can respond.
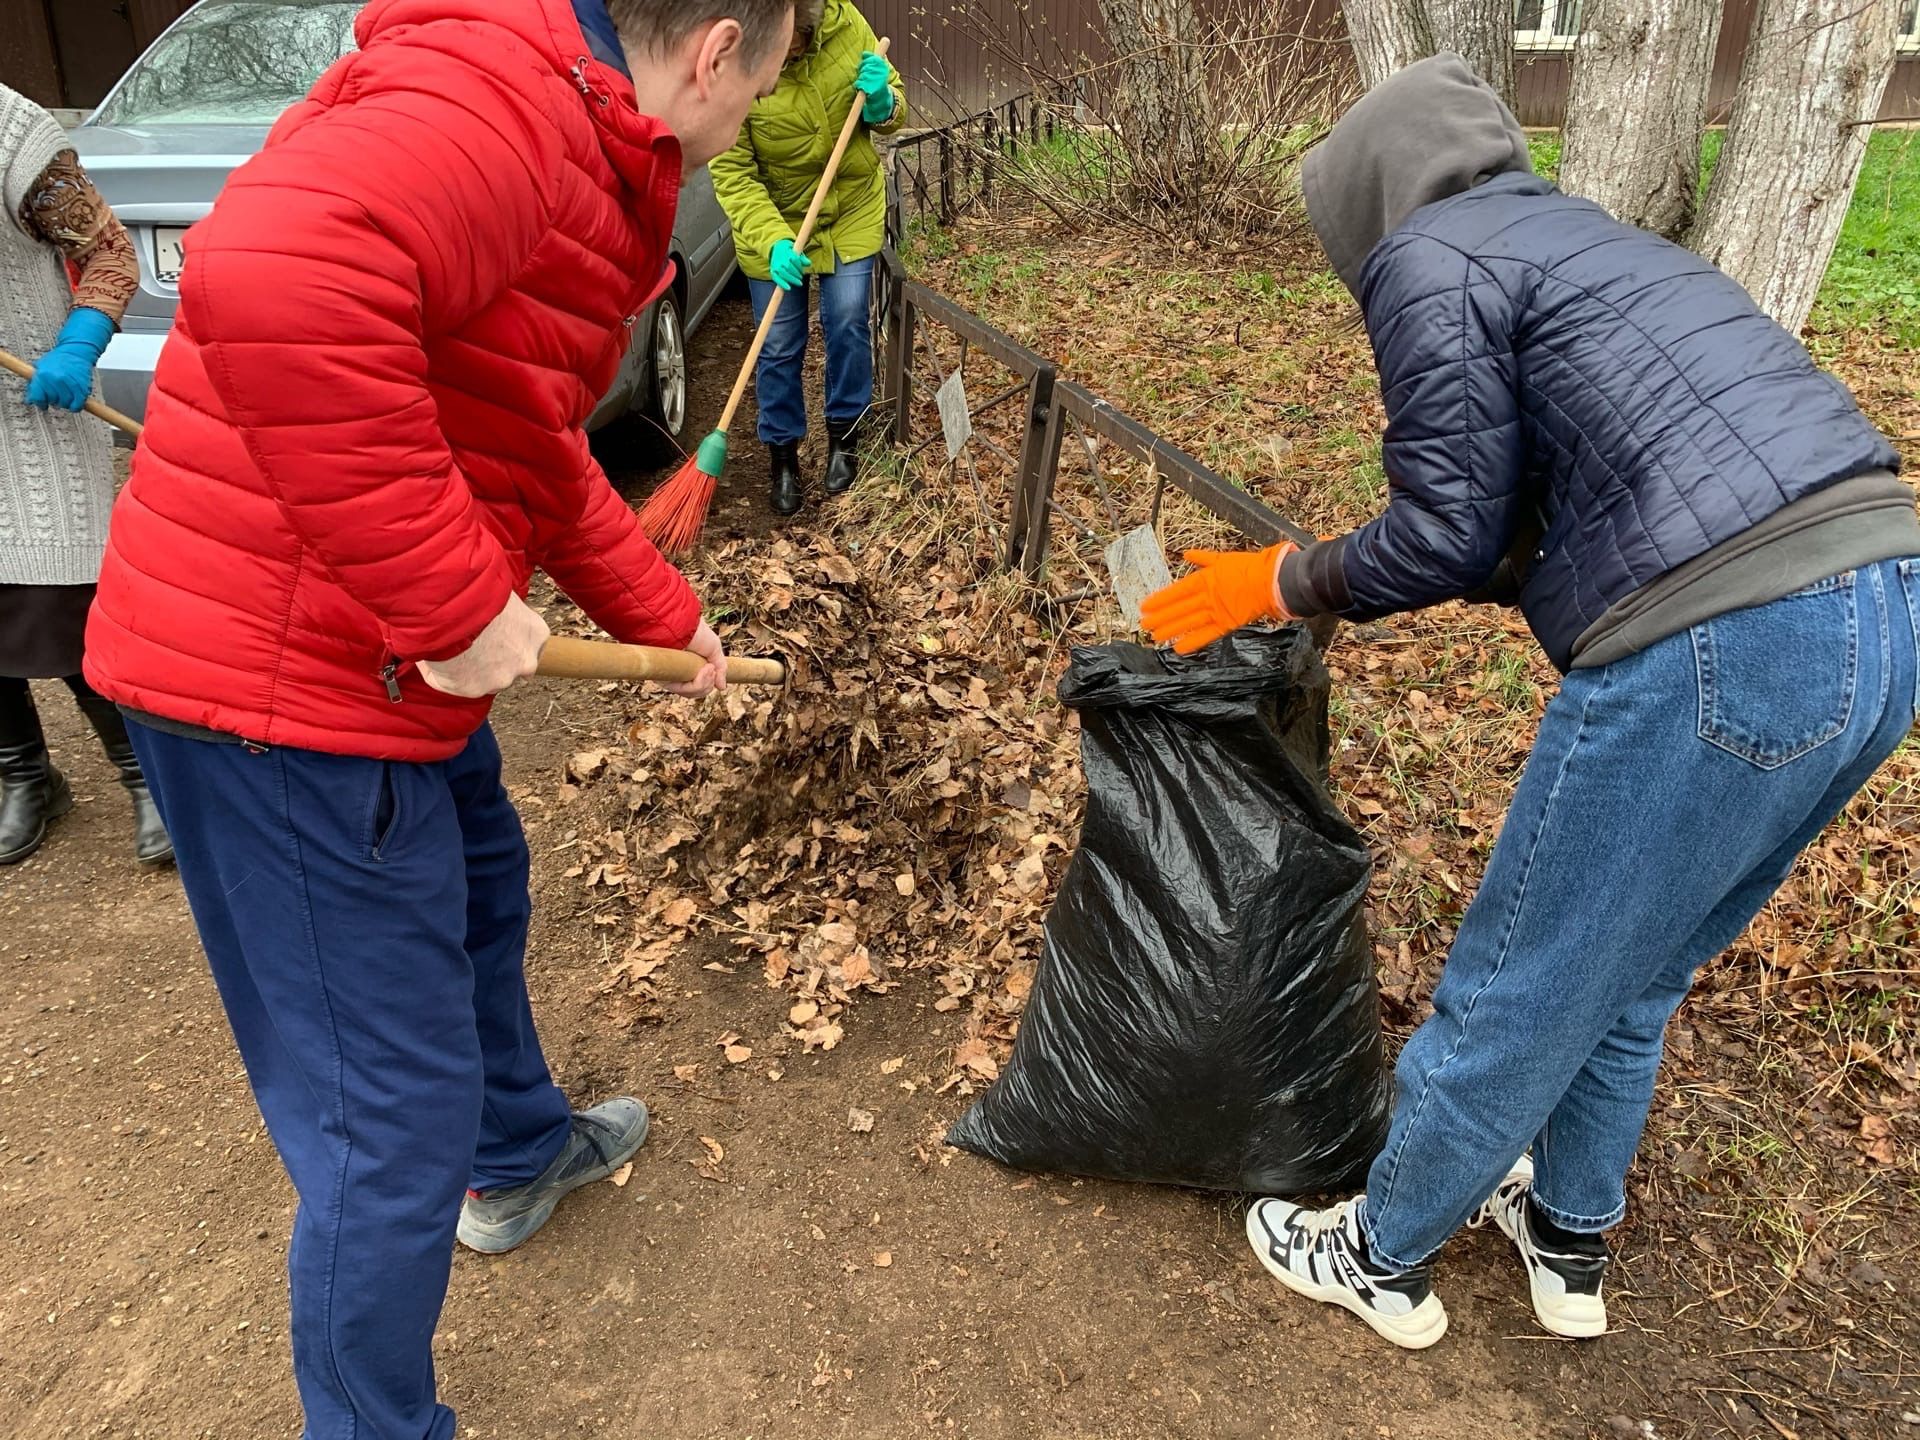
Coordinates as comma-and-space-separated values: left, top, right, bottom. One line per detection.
541, 480, 1092, 1085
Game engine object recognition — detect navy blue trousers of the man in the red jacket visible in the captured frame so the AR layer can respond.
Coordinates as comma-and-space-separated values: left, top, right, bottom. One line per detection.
127, 724, 568, 1440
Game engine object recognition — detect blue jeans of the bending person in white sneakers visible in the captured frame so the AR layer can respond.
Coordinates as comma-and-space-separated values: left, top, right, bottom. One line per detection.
1365, 561, 1920, 1267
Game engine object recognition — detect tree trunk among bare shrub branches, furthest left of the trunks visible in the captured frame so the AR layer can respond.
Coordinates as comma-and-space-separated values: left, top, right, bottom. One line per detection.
1100, 0, 1215, 198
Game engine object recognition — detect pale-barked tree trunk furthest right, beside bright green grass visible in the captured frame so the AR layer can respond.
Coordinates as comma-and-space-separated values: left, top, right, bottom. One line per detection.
1693, 0, 1899, 334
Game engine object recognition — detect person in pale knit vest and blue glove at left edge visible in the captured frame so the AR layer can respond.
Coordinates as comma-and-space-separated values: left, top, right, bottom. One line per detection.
0, 84, 173, 864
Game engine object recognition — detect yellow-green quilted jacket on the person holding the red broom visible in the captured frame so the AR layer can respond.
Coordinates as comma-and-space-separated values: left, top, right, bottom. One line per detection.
712, 0, 906, 280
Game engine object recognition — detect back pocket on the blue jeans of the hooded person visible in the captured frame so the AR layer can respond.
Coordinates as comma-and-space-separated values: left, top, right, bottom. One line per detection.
1692, 570, 1860, 770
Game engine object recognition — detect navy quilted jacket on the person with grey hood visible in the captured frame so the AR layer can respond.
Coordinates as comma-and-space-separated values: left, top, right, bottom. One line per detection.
1302, 173, 1899, 668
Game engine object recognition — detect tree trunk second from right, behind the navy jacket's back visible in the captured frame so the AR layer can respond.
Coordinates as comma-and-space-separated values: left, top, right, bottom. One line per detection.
1559, 0, 1720, 240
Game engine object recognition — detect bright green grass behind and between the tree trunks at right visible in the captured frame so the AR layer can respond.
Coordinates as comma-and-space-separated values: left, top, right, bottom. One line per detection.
1528, 131, 1920, 346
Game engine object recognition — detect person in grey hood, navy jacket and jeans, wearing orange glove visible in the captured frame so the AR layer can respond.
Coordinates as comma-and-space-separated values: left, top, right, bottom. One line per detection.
1142, 56, 1920, 1348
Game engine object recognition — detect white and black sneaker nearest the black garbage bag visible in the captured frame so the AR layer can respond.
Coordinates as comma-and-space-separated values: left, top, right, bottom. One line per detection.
1246, 1200, 1446, 1350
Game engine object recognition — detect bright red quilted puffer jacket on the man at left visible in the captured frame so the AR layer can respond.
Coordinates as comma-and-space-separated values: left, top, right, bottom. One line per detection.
86, 0, 699, 760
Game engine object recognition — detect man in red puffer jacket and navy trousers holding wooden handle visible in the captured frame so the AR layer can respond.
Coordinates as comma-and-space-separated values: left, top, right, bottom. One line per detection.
86, 0, 793, 1440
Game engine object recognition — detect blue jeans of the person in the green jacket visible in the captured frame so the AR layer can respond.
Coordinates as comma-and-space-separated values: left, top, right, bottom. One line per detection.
747, 255, 874, 445
